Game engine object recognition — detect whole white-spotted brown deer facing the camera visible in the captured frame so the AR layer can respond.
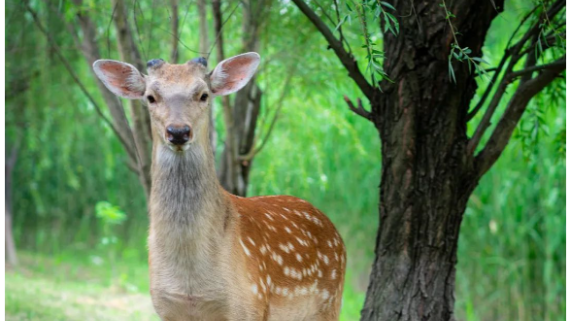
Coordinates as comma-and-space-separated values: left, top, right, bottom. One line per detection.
93, 52, 346, 321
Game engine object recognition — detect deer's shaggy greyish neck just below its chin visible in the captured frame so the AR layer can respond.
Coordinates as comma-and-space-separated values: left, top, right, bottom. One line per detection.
150, 140, 227, 236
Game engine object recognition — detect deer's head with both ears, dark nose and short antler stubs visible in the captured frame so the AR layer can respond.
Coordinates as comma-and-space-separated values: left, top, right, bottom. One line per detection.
93, 52, 259, 152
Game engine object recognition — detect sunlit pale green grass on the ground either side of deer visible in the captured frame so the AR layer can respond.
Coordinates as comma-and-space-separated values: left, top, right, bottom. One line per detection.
5, 252, 364, 321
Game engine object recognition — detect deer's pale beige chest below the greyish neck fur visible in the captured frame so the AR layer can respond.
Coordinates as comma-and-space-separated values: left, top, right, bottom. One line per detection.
149, 226, 233, 320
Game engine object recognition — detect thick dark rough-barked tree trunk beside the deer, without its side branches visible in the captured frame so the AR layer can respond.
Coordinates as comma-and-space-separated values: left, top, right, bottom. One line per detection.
362, 1, 503, 321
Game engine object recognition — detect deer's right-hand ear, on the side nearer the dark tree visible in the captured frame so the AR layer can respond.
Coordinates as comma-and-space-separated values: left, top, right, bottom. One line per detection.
210, 52, 259, 96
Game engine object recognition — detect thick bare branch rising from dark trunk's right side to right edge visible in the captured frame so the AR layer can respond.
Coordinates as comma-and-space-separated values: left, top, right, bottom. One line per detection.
475, 56, 566, 177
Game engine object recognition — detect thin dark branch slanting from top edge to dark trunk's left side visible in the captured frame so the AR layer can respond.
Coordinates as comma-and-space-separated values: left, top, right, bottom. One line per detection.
293, 0, 375, 100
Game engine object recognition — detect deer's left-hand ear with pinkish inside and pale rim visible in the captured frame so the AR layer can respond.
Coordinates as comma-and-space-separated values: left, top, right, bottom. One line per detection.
93, 59, 146, 99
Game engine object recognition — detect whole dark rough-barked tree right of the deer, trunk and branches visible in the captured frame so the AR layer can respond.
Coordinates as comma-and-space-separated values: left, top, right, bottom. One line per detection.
293, 0, 565, 320
